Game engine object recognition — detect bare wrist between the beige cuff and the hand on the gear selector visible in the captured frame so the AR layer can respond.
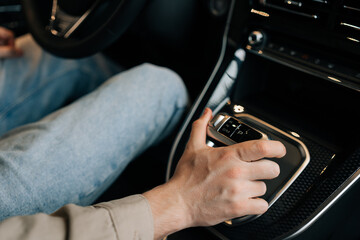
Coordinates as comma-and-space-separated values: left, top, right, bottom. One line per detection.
143, 182, 192, 239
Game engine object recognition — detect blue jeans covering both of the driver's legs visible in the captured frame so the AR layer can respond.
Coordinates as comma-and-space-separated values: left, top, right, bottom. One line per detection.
0, 36, 188, 220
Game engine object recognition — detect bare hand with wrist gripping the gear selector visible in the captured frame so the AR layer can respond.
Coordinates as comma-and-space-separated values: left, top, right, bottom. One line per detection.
144, 109, 286, 239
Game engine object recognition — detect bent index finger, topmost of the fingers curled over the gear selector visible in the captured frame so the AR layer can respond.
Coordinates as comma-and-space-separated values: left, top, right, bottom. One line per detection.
230, 140, 286, 162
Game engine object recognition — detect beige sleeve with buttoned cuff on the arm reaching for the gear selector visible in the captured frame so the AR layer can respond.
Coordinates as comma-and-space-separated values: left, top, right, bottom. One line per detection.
0, 195, 154, 240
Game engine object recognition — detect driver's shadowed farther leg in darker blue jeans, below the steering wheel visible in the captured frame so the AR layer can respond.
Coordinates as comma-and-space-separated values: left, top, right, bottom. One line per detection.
0, 35, 120, 135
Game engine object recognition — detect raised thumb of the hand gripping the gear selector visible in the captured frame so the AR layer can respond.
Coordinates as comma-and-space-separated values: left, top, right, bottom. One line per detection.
188, 108, 212, 148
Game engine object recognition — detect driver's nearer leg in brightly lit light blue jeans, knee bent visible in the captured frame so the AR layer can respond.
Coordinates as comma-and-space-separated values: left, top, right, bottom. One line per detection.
0, 62, 187, 219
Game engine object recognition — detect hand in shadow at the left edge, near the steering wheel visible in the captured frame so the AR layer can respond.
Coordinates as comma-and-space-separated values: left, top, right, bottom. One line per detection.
0, 27, 23, 58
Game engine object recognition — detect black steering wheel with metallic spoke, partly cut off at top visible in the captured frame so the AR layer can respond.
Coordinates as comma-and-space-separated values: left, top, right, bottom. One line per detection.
22, 0, 146, 58
